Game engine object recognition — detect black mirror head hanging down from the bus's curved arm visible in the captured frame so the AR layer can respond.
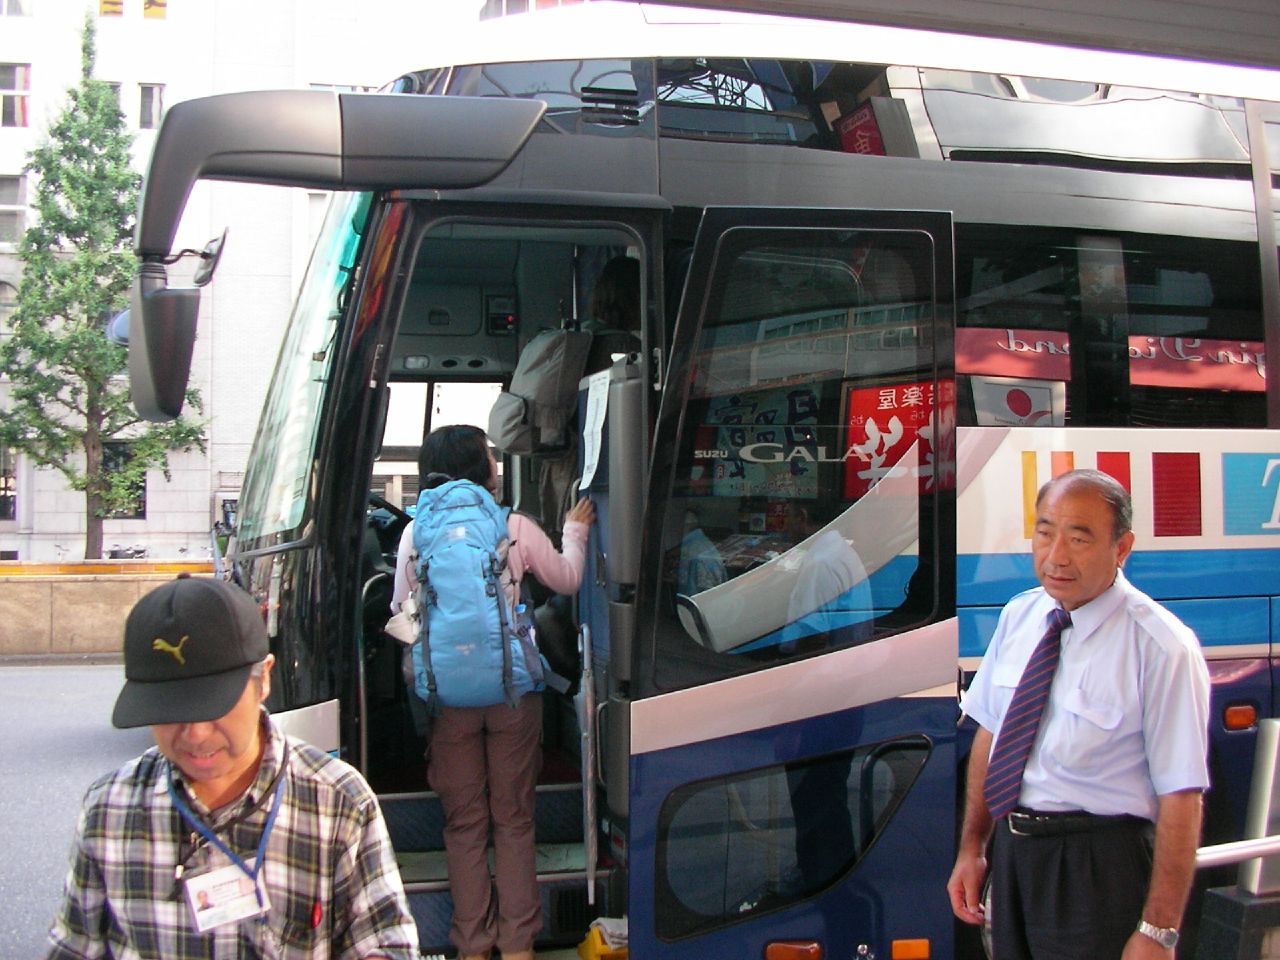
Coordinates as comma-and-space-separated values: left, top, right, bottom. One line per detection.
129, 261, 200, 421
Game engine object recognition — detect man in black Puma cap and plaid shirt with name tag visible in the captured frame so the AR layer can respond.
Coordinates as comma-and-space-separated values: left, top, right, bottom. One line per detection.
46, 577, 419, 960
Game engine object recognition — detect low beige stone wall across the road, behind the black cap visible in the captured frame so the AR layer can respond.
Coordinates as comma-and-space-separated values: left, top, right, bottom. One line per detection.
0, 563, 210, 657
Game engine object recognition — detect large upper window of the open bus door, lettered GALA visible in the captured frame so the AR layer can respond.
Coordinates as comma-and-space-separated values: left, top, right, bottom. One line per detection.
659, 229, 950, 669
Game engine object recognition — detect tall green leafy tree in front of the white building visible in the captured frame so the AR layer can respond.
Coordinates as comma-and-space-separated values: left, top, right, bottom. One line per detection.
0, 17, 204, 559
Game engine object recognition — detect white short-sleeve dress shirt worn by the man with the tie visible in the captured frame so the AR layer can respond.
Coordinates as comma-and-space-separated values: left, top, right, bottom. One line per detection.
961, 573, 1210, 820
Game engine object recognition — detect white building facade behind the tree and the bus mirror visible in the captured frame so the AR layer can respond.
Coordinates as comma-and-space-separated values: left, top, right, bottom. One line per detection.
0, 0, 460, 562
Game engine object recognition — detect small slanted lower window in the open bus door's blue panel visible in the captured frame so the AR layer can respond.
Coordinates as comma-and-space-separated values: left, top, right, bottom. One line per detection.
654, 737, 929, 940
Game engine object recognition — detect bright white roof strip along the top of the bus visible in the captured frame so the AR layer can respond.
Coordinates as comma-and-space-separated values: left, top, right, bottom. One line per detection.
424, 0, 1280, 101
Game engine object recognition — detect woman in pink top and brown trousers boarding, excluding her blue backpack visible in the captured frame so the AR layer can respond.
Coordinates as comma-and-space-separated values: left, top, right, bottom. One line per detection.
392, 425, 595, 960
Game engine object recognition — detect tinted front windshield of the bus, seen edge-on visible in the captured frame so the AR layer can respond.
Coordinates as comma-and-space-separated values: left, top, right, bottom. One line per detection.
237, 193, 372, 544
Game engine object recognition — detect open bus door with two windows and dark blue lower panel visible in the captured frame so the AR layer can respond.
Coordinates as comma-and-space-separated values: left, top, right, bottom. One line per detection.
619, 207, 957, 960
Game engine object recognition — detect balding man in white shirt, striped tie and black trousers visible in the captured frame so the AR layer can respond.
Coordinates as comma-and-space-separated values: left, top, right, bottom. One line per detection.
947, 470, 1208, 960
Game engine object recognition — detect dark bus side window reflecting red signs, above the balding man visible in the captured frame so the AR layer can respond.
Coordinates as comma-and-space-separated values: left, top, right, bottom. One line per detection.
956, 225, 1266, 426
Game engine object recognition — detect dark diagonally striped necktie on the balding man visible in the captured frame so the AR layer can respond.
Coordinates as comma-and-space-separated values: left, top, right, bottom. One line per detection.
982, 607, 1071, 820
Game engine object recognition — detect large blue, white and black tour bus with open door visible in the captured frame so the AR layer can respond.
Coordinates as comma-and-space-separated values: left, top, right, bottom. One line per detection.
129, 3, 1280, 960
